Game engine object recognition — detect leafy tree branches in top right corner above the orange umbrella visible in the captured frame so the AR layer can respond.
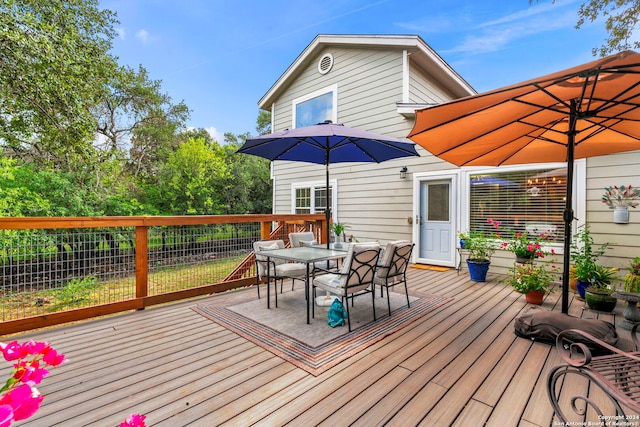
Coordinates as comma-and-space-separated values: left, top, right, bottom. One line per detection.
576, 0, 640, 56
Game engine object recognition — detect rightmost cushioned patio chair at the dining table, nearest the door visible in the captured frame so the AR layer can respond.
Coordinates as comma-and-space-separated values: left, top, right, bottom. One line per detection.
373, 240, 414, 316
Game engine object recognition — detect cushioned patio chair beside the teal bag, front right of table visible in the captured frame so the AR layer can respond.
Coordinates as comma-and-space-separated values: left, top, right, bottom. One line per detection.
311, 243, 380, 332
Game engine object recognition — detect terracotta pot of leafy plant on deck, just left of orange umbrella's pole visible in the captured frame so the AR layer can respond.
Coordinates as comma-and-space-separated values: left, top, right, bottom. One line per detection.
507, 263, 556, 305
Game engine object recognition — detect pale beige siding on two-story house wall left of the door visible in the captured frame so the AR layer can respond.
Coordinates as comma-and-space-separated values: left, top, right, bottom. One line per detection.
274, 47, 462, 246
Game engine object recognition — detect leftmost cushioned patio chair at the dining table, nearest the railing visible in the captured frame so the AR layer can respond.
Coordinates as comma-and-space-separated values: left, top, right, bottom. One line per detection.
253, 240, 307, 300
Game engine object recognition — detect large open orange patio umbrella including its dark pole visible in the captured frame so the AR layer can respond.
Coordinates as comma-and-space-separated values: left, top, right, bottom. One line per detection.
409, 51, 640, 313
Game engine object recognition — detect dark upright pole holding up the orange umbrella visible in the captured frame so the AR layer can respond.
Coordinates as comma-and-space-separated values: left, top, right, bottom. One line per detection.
562, 106, 577, 314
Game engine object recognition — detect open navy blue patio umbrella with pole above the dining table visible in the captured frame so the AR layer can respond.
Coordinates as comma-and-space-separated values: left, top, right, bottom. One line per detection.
237, 121, 418, 247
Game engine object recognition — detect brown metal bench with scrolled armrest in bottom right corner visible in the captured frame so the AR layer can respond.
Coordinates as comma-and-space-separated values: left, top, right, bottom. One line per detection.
547, 323, 640, 425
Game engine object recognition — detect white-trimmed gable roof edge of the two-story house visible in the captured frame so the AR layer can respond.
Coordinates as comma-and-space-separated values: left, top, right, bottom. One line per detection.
258, 34, 476, 110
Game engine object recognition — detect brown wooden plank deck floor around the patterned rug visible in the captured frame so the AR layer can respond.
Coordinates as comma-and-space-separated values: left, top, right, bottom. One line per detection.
0, 268, 628, 427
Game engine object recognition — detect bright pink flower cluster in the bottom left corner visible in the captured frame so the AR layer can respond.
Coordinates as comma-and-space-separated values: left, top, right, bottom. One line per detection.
0, 341, 66, 427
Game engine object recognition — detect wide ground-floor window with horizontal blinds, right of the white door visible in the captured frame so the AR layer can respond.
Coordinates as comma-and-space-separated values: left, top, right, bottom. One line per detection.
469, 168, 567, 242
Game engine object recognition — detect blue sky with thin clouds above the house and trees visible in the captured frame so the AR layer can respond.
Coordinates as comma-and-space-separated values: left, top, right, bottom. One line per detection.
100, 0, 606, 142
